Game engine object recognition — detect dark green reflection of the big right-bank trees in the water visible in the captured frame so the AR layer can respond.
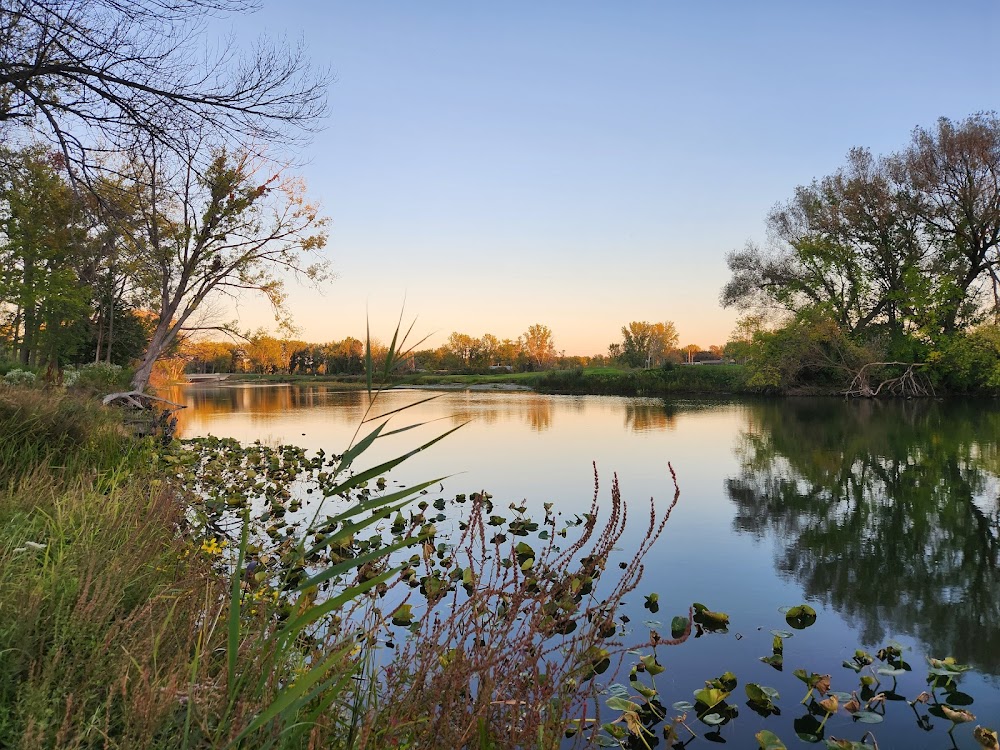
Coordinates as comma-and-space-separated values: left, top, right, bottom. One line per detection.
726, 399, 1000, 674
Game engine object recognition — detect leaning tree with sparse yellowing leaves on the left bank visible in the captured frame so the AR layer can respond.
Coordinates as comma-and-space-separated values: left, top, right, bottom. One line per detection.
116, 137, 327, 391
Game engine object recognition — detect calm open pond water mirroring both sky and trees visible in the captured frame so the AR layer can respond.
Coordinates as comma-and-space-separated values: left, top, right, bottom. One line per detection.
165, 384, 1000, 750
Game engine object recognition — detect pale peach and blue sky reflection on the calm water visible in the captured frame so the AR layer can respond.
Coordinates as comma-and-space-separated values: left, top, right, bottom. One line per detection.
165, 386, 1000, 748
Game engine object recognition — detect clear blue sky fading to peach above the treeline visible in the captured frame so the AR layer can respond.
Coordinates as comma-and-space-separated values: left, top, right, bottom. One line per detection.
219, 0, 1000, 355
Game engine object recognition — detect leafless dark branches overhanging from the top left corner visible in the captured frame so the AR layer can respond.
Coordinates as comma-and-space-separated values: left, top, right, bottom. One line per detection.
0, 0, 327, 177
